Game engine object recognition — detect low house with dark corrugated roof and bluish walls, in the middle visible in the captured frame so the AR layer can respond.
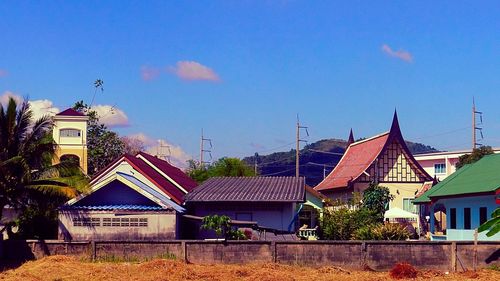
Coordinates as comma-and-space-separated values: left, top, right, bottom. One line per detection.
185, 177, 306, 238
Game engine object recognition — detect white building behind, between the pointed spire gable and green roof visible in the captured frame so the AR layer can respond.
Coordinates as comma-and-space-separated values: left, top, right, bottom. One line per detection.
414, 148, 500, 181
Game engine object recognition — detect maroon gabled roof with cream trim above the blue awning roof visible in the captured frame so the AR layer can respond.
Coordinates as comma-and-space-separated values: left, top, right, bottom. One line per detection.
90, 153, 196, 204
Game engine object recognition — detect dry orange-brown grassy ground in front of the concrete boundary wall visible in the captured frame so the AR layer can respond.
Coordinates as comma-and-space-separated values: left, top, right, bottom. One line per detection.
0, 256, 500, 281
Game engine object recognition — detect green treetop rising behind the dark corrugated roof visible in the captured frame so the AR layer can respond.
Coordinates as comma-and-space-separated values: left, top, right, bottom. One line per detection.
187, 157, 256, 183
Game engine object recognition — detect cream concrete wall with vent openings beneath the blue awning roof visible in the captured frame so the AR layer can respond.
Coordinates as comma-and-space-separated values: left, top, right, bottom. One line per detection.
58, 211, 177, 241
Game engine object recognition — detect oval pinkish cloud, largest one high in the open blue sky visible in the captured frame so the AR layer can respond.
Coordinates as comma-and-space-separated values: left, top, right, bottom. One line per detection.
169, 61, 220, 82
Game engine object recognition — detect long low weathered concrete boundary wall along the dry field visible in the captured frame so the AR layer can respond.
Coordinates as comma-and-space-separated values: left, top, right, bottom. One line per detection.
0, 240, 500, 271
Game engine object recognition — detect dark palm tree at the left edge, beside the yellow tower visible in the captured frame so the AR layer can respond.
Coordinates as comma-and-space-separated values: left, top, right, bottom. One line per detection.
0, 98, 86, 237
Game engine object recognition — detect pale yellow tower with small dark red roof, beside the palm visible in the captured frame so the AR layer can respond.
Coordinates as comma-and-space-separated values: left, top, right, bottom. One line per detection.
52, 108, 89, 174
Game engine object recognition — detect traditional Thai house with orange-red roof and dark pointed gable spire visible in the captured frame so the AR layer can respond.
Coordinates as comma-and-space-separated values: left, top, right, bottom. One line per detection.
314, 112, 433, 213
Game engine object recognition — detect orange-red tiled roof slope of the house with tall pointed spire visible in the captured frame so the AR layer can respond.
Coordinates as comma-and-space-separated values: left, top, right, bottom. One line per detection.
314, 132, 389, 190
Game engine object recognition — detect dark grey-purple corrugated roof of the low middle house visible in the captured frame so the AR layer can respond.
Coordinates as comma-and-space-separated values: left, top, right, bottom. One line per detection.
186, 177, 305, 202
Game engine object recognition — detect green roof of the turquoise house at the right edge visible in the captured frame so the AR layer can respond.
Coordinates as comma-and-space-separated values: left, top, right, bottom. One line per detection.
413, 154, 500, 204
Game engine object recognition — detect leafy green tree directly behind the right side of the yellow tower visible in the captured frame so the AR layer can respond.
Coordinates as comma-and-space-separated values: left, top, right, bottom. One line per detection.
73, 101, 125, 176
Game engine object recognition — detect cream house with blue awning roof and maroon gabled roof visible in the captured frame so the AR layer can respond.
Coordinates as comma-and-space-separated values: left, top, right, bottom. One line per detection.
59, 152, 197, 240
